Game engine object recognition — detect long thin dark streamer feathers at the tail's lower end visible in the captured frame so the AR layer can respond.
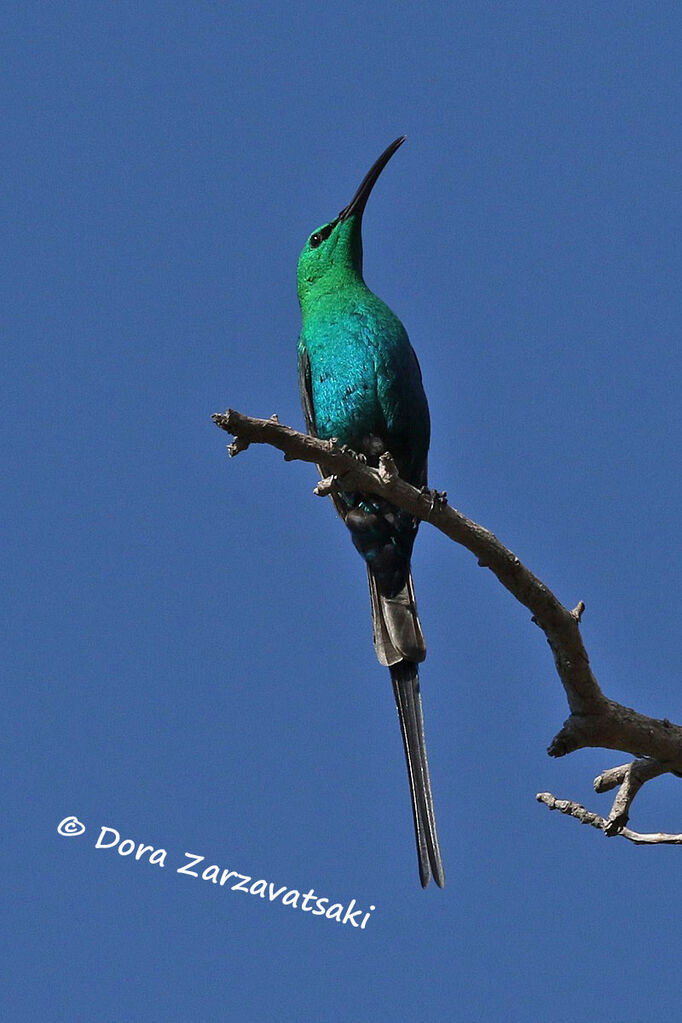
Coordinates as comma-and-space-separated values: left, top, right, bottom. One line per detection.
390, 661, 445, 888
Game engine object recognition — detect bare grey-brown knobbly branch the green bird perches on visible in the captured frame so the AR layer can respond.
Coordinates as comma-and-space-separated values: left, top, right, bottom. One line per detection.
213, 409, 682, 844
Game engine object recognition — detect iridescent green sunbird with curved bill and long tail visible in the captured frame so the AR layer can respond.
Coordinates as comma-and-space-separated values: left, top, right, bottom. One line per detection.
297, 135, 445, 888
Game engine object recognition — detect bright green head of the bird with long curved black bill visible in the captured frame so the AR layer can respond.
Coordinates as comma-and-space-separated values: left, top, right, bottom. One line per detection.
297, 135, 405, 307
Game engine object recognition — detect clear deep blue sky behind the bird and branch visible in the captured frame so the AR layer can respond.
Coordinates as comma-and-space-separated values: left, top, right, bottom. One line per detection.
6, 0, 682, 1023
